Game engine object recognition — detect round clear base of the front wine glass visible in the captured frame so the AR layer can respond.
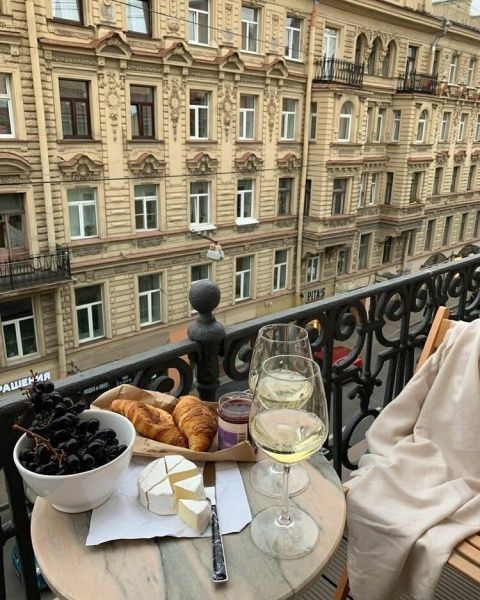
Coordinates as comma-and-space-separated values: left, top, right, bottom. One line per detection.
250, 506, 319, 560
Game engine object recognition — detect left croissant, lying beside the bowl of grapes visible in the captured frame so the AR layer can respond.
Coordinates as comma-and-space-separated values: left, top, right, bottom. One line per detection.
110, 400, 188, 448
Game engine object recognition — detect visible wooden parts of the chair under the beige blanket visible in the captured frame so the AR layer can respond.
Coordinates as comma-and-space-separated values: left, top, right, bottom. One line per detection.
334, 306, 480, 600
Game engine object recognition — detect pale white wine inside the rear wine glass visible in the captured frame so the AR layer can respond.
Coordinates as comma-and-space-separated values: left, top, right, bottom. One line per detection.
255, 369, 313, 408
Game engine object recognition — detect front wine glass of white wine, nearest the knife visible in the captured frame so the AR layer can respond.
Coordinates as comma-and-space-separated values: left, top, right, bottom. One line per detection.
250, 355, 328, 559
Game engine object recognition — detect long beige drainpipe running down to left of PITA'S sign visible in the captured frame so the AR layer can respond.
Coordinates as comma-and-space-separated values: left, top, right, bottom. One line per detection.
295, 0, 319, 304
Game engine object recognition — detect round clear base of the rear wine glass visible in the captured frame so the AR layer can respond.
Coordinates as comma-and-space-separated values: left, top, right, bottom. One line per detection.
250, 459, 310, 498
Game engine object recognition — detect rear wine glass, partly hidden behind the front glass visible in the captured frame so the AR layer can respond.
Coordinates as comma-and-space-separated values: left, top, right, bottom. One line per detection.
248, 323, 312, 498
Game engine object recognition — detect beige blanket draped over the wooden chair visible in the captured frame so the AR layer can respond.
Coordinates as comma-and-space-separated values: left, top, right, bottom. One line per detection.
347, 320, 480, 600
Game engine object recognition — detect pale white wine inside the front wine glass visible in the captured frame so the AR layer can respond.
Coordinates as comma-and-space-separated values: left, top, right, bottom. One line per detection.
250, 408, 327, 464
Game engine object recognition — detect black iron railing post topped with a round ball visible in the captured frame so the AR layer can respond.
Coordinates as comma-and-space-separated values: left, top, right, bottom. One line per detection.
188, 279, 225, 402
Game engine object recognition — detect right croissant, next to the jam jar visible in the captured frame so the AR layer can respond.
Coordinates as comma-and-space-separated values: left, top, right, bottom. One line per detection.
172, 396, 218, 452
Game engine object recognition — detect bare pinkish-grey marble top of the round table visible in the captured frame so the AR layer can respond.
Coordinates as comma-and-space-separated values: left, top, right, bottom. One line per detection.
32, 454, 346, 600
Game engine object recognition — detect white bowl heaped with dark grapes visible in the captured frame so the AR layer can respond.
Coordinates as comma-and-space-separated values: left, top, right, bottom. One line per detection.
13, 381, 135, 513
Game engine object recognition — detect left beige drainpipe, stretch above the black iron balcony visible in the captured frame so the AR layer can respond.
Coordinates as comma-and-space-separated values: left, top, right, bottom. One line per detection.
25, 0, 55, 253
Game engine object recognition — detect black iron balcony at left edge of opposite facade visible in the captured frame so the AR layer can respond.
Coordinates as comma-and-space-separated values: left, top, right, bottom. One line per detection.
0, 246, 71, 292
